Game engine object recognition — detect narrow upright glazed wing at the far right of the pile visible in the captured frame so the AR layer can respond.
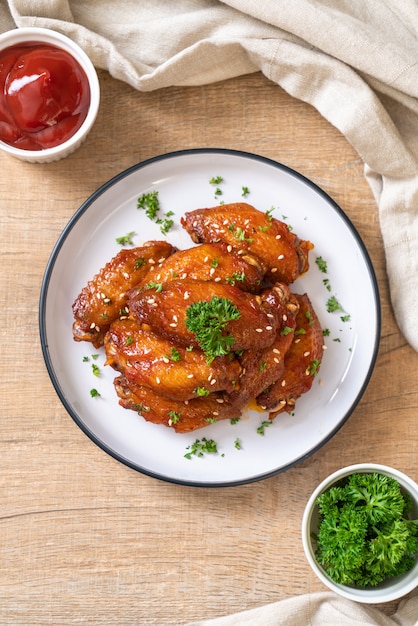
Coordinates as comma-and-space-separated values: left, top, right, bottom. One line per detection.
257, 294, 324, 418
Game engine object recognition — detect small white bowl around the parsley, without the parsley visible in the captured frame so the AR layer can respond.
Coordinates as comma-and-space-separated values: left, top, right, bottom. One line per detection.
302, 463, 418, 604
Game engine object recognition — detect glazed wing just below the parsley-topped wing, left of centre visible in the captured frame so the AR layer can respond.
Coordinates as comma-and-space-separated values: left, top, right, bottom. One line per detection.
105, 319, 241, 401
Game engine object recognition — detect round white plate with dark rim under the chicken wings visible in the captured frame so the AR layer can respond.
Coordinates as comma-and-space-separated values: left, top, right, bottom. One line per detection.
40, 149, 380, 487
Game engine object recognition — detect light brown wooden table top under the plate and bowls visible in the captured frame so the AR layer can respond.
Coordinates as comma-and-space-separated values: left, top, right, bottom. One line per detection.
0, 72, 418, 626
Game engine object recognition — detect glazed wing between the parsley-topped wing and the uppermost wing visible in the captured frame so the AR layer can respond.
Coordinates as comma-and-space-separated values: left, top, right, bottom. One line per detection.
134, 243, 263, 292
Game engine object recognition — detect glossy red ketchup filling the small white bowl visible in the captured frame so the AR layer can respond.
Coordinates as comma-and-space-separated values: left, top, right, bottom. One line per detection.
0, 43, 90, 150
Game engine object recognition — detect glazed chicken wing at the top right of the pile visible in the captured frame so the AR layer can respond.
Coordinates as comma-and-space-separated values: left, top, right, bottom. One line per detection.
181, 202, 313, 284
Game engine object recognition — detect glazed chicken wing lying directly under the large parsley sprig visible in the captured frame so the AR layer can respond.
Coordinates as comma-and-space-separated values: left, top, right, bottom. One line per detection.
129, 279, 278, 351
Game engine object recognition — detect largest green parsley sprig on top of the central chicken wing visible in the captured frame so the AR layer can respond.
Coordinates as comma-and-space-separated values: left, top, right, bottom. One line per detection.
186, 296, 241, 363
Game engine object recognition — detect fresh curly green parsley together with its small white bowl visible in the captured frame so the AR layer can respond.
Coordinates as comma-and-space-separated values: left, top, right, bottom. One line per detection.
302, 463, 418, 604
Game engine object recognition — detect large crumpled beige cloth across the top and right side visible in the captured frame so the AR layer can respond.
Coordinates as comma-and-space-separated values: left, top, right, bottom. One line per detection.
0, 0, 418, 351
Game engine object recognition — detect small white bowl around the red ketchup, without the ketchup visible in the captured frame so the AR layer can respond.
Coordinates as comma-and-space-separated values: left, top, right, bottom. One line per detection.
0, 27, 100, 163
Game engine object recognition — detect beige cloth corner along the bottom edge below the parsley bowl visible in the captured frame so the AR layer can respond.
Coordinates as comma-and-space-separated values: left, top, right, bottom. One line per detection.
187, 592, 418, 626
